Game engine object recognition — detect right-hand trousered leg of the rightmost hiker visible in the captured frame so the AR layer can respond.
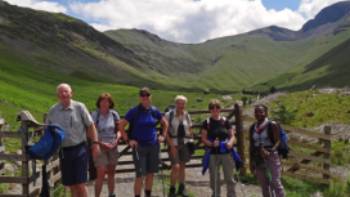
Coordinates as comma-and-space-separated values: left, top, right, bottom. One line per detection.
268, 152, 285, 197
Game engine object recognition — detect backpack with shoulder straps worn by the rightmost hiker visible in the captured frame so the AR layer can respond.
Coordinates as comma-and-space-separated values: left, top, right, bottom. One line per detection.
250, 121, 289, 158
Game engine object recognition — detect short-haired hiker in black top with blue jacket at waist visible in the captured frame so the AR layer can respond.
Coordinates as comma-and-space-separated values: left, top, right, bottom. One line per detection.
201, 99, 236, 197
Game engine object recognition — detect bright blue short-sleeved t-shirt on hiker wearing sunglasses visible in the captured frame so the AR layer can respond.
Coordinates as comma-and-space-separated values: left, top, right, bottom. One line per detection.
125, 105, 162, 145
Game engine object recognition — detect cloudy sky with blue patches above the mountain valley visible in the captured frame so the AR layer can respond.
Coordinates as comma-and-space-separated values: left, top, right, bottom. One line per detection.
5, 0, 341, 43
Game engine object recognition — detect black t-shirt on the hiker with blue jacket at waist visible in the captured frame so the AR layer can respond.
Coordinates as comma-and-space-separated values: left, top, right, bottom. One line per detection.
202, 118, 232, 154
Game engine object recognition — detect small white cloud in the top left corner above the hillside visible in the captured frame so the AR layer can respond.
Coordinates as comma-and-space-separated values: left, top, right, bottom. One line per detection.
6, 0, 67, 13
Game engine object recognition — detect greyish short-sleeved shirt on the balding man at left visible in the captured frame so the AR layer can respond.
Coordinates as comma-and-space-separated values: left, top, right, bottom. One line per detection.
46, 100, 93, 147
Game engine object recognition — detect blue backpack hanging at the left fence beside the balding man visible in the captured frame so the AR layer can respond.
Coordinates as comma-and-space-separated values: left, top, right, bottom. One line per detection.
27, 125, 64, 160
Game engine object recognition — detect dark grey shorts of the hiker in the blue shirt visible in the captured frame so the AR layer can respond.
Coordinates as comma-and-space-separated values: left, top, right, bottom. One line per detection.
133, 144, 159, 177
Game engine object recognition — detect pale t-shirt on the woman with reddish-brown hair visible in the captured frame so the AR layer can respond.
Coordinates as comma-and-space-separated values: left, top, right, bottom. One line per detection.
92, 110, 120, 143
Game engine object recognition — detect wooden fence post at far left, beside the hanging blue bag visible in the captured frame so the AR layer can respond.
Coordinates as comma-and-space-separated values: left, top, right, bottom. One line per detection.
20, 121, 30, 196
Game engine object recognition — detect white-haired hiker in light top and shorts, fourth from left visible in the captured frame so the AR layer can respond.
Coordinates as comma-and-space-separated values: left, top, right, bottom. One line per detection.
165, 95, 193, 197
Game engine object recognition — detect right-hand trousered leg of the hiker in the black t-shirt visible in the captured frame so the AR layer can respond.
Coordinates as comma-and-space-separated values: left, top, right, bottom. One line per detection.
220, 154, 236, 197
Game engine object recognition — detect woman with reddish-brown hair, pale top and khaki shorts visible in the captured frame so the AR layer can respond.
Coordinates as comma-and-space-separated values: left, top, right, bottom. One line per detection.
92, 93, 121, 197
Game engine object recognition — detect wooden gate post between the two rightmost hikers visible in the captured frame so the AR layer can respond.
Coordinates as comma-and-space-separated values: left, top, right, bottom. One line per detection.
234, 103, 246, 175
